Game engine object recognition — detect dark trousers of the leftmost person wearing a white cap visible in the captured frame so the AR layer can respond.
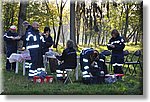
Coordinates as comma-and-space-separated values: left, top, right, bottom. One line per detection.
6, 48, 17, 71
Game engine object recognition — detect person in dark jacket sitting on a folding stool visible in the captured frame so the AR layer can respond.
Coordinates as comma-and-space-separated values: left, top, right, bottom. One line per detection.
56, 40, 77, 80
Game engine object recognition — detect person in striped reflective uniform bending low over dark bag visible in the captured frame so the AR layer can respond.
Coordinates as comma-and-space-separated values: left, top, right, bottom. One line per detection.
80, 48, 107, 84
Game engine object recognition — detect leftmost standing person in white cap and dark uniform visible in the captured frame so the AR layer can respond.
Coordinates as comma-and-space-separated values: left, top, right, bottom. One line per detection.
3, 25, 21, 71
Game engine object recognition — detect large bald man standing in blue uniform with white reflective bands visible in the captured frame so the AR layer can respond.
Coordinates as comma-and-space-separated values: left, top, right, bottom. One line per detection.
26, 22, 44, 80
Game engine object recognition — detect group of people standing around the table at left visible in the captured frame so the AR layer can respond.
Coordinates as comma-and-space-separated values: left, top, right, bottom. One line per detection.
3, 21, 53, 79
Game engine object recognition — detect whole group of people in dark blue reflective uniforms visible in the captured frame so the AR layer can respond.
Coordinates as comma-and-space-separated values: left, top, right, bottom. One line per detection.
3, 21, 125, 81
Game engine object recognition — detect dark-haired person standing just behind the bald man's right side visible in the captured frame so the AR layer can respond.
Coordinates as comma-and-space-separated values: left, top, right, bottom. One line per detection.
42, 27, 54, 55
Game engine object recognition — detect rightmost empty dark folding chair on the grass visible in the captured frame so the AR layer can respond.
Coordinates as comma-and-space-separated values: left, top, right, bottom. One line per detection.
125, 50, 143, 75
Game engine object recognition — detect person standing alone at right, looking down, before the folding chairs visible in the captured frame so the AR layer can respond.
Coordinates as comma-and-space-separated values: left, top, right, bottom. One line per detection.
107, 29, 125, 74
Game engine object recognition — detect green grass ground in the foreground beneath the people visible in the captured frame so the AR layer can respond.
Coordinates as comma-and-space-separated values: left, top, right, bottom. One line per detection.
2, 46, 143, 95
